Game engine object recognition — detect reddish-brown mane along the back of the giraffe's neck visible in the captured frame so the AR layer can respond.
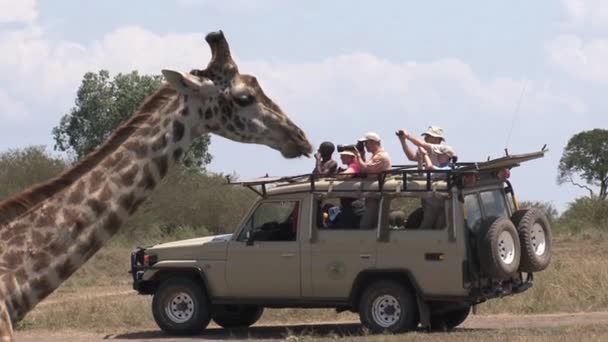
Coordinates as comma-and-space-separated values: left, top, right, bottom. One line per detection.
0, 84, 177, 229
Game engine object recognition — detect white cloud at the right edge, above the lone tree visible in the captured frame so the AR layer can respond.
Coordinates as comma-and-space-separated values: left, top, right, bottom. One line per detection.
546, 34, 608, 83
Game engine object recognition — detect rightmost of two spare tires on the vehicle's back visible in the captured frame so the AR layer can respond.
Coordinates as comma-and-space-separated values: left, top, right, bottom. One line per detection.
511, 208, 552, 273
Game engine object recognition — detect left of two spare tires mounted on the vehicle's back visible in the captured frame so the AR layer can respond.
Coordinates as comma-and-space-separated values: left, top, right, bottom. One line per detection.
477, 217, 521, 279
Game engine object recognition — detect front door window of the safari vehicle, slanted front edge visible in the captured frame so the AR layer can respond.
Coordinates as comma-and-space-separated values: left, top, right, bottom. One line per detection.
238, 201, 300, 241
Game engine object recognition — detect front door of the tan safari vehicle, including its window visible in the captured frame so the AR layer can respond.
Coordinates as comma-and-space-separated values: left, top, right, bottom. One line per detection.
226, 200, 301, 298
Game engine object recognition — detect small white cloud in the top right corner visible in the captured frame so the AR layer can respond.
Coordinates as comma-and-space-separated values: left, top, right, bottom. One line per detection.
562, 0, 608, 27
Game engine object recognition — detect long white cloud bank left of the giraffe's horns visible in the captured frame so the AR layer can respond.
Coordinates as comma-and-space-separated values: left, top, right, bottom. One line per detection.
0, 25, 210, 102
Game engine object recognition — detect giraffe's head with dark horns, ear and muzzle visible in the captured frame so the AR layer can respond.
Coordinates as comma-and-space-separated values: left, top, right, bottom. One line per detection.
163, 31, 312, 158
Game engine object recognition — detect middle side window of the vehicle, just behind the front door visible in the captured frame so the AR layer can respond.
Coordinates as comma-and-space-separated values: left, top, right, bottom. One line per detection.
316, 197, 370, 229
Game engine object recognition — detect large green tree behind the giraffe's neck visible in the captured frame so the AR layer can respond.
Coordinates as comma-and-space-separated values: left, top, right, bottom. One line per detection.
53, 70, 211, 170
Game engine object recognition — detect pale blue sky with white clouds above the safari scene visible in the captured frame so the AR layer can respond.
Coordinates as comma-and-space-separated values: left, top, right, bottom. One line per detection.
0, 0, 608, 210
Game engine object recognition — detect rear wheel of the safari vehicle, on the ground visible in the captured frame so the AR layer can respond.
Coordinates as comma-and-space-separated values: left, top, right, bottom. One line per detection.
359, 280, 418, 333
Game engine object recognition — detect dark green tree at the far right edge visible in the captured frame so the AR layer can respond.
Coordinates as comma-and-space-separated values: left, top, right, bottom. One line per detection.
557, 129, 608, 200
